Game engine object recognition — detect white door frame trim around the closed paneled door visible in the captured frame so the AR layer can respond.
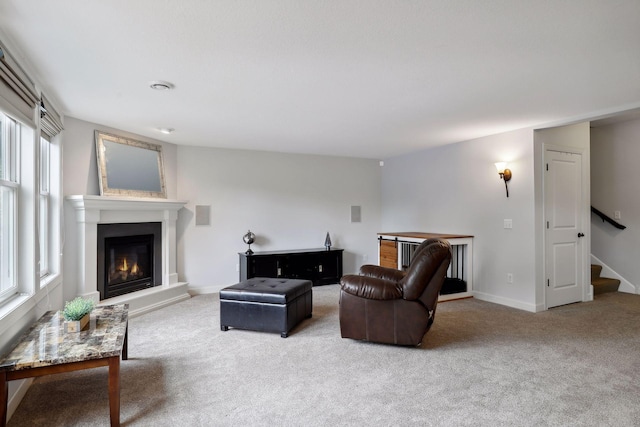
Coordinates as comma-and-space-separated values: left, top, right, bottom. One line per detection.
542, 142, 593, 310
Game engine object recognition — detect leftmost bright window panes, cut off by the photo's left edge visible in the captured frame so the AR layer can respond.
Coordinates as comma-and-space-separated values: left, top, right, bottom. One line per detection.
0, 113, 21, 301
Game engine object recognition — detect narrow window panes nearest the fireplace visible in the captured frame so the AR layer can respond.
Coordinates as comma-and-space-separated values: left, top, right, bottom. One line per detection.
38, 134, 51, 279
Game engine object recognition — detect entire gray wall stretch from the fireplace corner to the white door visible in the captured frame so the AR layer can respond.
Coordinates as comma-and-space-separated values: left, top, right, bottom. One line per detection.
64, 118, 608, 311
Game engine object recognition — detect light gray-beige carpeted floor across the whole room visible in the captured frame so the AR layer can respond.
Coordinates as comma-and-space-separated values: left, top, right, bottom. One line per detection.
9, 285, 640, 427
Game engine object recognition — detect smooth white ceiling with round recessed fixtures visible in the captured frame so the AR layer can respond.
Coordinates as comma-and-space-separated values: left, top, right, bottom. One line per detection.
0, 0, 640, 159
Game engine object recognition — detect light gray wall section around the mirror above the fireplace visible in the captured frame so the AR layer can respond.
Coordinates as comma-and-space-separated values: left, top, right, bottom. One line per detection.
62, 117, 177, 301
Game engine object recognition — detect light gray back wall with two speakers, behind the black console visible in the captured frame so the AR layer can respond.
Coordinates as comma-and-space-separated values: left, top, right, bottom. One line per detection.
178, 146, 381, 291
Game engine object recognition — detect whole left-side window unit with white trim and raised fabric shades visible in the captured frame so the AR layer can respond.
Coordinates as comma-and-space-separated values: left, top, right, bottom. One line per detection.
0, 43, 63, 310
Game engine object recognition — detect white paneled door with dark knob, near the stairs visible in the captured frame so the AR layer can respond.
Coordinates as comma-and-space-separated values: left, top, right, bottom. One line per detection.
544, 149, 585, 308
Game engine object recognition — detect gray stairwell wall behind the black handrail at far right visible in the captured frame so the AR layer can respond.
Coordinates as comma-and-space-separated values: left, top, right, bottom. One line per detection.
591, 120, 640, 292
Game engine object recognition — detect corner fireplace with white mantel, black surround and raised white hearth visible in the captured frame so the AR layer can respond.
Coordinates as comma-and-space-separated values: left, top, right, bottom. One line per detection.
65, 195, 191, 316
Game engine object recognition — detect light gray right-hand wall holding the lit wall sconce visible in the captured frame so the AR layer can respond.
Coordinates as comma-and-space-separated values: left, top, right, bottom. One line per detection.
381, 129, 536, 311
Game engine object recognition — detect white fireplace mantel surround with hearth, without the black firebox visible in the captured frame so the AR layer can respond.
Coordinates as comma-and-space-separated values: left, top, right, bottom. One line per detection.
66, 195, 189, 314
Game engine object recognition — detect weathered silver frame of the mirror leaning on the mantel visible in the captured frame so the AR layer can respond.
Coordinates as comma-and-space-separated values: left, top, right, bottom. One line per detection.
95, 130, 167, 199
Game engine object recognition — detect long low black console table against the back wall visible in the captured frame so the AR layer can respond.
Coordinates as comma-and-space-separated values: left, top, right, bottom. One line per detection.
238, 248, 344, 286
